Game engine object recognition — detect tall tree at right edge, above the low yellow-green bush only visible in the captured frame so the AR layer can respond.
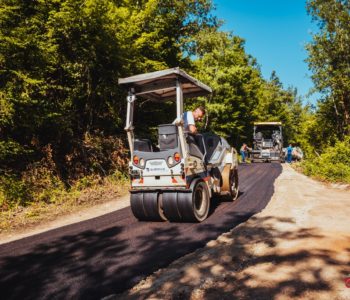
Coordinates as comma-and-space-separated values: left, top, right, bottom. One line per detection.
307, 0, 350, 138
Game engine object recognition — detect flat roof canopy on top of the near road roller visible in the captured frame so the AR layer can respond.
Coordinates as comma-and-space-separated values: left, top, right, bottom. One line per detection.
118, 67, 212, 101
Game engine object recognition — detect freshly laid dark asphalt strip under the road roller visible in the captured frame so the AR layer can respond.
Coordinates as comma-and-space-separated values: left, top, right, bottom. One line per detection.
0, 163, 282, 300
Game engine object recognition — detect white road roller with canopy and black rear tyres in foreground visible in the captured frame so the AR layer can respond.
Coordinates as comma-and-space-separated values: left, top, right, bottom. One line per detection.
118, 68, 239, 222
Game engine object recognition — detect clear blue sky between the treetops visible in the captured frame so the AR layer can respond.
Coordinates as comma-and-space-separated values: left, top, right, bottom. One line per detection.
214, 0, 318, 104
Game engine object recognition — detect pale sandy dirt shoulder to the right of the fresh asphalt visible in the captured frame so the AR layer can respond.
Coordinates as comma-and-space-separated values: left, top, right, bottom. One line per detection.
113, 164, 350, 300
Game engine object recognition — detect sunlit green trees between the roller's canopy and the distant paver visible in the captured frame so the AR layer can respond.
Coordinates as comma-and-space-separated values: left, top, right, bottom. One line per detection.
188, 30, 305, 146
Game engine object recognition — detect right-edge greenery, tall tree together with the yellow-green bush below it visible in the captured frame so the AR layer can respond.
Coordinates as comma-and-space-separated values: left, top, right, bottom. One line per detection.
300, 0, 350, 178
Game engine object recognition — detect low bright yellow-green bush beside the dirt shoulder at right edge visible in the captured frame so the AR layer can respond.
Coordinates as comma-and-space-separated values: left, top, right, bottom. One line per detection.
302, 136, 350, 183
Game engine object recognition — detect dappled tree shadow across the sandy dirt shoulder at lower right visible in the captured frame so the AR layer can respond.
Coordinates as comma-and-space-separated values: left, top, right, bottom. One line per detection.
121, 213, 350, 300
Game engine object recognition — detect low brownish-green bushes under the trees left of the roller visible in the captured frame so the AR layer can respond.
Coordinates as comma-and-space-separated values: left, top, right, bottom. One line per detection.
0, 137, 128, 211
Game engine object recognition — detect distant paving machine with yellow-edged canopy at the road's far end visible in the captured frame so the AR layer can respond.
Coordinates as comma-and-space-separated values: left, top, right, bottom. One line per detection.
251, 122, 285, 162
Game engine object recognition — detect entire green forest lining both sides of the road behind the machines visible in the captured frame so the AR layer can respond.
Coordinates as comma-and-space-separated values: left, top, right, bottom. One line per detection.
0, 0, 350, 210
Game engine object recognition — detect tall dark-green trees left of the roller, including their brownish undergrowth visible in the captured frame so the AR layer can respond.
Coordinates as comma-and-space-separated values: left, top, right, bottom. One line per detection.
0, 0, 217, 209
